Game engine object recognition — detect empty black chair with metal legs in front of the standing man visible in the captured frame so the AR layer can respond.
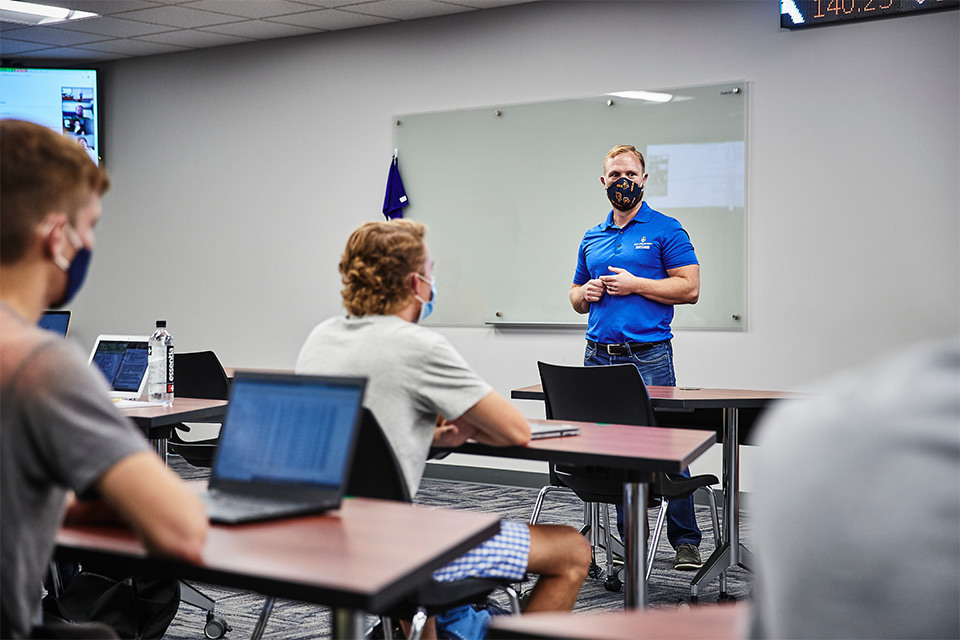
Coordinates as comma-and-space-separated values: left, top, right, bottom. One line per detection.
530, 362, 720, 591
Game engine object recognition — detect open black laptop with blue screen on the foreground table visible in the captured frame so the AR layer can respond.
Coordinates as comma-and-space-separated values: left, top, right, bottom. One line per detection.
202, 371, 367, 524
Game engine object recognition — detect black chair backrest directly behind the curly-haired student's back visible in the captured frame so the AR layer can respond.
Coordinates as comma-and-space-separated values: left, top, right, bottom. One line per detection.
346, 407, 413, 502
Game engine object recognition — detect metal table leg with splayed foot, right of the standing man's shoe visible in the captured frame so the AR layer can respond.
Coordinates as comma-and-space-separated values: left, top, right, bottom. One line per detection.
690, 407, 753, 597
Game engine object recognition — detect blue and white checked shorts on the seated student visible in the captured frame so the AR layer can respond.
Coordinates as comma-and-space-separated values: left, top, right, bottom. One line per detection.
433, 520, 530, 582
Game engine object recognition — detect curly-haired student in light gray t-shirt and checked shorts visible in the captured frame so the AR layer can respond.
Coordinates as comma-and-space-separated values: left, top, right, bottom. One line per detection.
297, 220, 590, 636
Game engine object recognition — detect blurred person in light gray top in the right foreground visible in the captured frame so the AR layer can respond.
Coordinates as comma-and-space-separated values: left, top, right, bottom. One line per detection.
750, 338, 960, 638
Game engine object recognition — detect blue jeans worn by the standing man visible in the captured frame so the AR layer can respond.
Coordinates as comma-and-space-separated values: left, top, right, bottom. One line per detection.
583, 340, 703, 549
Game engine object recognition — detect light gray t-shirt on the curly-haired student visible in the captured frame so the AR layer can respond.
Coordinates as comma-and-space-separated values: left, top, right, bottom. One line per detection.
297, 316, 492, 495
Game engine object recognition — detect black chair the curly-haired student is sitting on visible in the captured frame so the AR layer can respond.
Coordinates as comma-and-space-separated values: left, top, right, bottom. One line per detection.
346, 408, 520, 640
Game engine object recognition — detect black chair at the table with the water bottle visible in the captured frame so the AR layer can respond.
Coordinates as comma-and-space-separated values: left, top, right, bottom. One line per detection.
167, 351, 230, 467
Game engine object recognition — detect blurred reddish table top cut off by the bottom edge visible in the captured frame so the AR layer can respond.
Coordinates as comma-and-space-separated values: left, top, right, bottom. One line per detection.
488, 603, 750, 640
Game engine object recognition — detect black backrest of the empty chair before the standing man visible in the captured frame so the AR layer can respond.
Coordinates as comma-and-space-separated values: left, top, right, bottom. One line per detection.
537, 362, 657, 426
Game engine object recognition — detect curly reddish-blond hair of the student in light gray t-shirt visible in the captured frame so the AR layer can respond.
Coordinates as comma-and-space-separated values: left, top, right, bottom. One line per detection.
340, 220, 427, 316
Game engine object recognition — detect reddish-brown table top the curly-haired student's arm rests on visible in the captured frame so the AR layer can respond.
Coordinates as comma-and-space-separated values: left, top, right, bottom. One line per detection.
456, 420, 716, 472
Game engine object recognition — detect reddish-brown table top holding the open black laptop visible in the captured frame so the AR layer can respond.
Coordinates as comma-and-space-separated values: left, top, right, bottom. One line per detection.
57, 498, 500, 612
